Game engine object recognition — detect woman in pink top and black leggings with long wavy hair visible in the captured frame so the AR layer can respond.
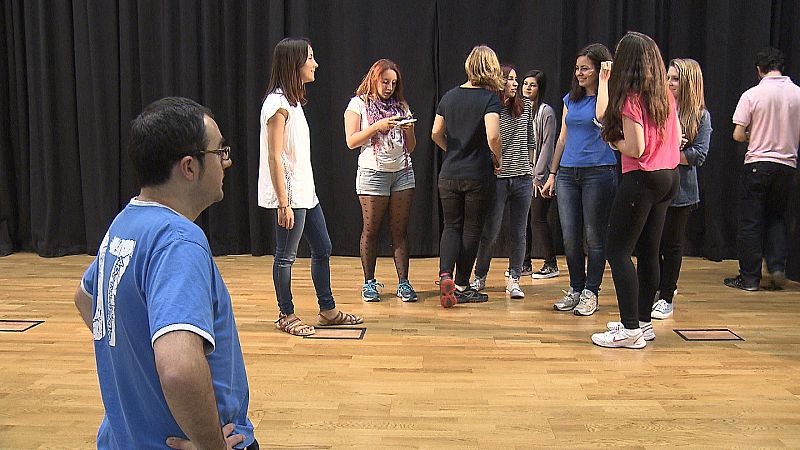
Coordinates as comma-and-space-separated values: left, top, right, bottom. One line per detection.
592, 32, 681, 348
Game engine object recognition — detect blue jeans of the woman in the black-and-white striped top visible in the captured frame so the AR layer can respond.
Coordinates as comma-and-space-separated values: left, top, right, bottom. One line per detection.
475, 175, 533, 277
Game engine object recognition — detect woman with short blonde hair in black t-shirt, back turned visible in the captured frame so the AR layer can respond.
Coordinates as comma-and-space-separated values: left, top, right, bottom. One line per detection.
431, 45, 505, 308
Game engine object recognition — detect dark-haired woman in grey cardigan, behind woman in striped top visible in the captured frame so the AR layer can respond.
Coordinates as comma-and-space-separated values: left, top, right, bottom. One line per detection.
522, 70, 560, 280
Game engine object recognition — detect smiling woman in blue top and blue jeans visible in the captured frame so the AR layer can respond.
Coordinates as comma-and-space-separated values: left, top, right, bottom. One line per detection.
542, 44, 617, 316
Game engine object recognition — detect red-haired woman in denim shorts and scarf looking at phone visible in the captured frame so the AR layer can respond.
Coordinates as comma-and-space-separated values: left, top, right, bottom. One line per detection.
344, 59, 417, 302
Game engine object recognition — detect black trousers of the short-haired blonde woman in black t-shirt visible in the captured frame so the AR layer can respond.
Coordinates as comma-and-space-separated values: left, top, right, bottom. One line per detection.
438, 177, 495, 286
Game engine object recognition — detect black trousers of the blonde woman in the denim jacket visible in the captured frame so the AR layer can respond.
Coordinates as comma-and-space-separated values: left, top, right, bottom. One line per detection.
658, 204, 697, 303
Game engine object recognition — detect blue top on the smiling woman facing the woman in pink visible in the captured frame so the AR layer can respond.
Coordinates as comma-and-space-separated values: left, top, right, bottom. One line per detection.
559, 93, 617, 167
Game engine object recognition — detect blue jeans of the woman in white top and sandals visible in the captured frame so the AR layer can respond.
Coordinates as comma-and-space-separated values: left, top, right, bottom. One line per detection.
272, 204, 336, 316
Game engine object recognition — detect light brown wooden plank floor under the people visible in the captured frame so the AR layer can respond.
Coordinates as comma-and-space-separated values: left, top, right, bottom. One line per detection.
0, 254, 800, 449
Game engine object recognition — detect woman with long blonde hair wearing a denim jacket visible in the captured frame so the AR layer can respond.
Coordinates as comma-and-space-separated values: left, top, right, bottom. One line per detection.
650, 59, 712, 319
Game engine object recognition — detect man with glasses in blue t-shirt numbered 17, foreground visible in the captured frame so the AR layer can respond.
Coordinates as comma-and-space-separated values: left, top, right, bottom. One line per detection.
75, 97, 258, 449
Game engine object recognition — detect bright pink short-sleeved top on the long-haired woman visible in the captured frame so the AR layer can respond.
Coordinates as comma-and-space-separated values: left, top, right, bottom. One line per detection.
622, 92, 681, 173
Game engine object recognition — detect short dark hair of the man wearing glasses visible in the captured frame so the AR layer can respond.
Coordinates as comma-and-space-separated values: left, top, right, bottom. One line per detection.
128, 97, 212, 188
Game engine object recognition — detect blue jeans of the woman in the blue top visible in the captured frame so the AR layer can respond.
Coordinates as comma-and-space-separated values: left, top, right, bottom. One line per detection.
556, 166, 617, 295
